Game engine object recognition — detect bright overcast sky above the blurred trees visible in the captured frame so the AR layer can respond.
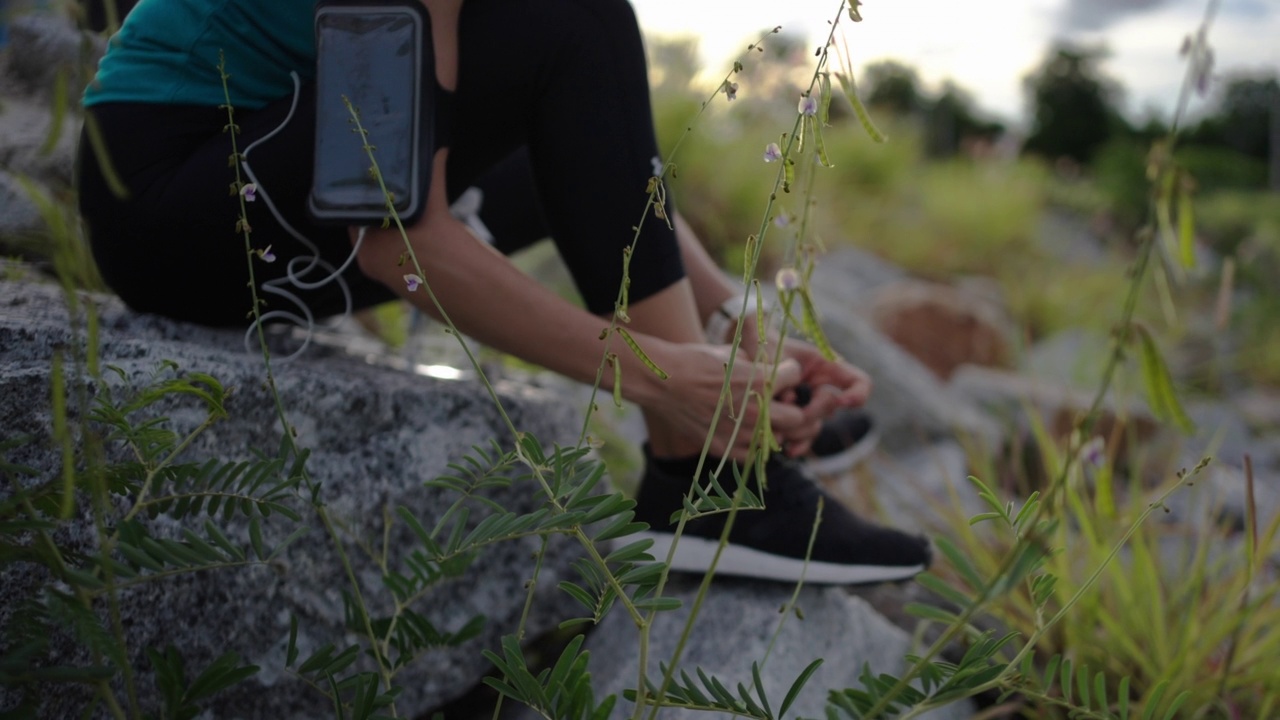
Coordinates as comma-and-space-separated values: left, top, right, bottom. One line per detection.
632, 0, 1280, 122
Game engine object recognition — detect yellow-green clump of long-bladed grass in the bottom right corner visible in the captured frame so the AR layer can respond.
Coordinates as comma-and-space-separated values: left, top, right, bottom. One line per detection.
950, 412, 1280, 717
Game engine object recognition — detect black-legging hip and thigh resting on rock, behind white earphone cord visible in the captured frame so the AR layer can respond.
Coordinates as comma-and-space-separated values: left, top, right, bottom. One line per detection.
78, 90, 393, 325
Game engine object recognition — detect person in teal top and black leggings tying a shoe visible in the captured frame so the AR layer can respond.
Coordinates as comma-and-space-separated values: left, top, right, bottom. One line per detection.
79, 0, 929, 583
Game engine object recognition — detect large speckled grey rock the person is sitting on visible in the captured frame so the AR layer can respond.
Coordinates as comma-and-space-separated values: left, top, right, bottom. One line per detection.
0, 272, 581, 720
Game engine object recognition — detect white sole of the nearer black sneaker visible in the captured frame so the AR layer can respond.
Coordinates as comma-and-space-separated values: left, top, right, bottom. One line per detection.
634, 532, 925, 585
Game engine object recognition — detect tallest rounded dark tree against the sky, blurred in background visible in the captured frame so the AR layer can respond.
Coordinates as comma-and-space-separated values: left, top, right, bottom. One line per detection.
1023, 42, 1126, 164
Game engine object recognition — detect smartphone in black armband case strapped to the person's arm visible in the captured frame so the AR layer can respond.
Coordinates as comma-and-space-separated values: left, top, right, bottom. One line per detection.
307, 0, 435, 225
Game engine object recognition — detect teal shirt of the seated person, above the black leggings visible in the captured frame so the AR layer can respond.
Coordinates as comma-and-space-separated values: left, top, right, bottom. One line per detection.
84, 0, 315, 109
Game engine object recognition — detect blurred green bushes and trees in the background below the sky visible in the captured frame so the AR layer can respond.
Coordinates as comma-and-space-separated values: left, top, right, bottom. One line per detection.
649, 35, 1280, 391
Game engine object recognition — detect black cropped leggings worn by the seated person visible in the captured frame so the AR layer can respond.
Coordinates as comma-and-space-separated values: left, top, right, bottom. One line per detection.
79, 0, 684, 325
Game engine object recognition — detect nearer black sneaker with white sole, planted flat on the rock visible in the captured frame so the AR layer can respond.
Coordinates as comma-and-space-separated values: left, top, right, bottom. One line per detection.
635, 446, 931, 584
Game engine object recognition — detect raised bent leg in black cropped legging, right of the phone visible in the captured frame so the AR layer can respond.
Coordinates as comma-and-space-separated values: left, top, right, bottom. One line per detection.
449, 0, 684, 313
